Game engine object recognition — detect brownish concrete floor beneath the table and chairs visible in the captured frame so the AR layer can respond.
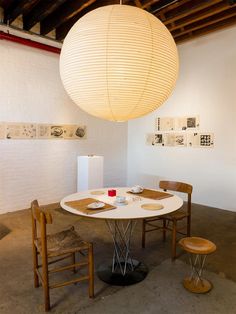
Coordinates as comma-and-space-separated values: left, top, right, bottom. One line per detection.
0, 205, 236, 314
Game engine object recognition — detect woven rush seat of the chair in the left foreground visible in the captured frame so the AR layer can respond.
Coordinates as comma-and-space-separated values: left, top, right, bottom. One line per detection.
35, 227, 88, 257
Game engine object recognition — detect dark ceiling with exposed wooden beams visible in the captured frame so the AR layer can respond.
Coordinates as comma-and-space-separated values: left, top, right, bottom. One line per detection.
0, 0, 236, 43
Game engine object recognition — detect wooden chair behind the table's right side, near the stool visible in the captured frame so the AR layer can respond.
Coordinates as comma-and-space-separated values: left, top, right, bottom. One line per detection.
142, 181, 193, 260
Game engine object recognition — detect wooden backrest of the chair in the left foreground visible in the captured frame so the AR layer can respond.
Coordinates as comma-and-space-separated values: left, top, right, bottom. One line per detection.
31, 200, 52, 245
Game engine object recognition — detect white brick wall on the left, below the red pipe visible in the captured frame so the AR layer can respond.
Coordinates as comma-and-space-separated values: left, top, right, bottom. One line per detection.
0, 41, 127, 213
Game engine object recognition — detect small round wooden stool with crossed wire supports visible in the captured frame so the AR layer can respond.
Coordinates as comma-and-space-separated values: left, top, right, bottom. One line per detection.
179, 237, 216, 293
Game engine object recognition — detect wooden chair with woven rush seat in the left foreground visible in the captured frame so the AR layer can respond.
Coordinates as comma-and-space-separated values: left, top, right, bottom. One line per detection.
31, 200, 94, 311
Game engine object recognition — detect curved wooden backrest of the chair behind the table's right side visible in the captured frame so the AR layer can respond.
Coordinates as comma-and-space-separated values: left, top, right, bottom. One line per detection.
159, 181, 193, 215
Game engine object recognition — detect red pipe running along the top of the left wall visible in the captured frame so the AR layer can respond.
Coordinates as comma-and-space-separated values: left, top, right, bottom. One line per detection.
0, 31, 61, 54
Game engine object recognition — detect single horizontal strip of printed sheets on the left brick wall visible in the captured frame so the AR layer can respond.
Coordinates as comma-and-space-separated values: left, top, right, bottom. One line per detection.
0, 122, 87, 140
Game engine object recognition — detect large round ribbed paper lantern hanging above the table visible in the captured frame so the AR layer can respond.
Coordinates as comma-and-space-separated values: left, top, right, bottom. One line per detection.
60, 5, 178, 121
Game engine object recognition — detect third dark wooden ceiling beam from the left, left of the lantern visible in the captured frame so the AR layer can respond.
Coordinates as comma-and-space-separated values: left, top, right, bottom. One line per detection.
40, 0, 99, 35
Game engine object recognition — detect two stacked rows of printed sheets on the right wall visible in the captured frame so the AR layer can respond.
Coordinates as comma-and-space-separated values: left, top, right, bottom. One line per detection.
146, 116, 214, 147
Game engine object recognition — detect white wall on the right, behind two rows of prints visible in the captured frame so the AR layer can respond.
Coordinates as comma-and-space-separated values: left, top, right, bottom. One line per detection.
127, 26, 236, 212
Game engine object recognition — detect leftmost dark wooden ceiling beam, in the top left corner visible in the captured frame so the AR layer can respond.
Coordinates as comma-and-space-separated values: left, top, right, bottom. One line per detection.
4, 0, 40, 24
